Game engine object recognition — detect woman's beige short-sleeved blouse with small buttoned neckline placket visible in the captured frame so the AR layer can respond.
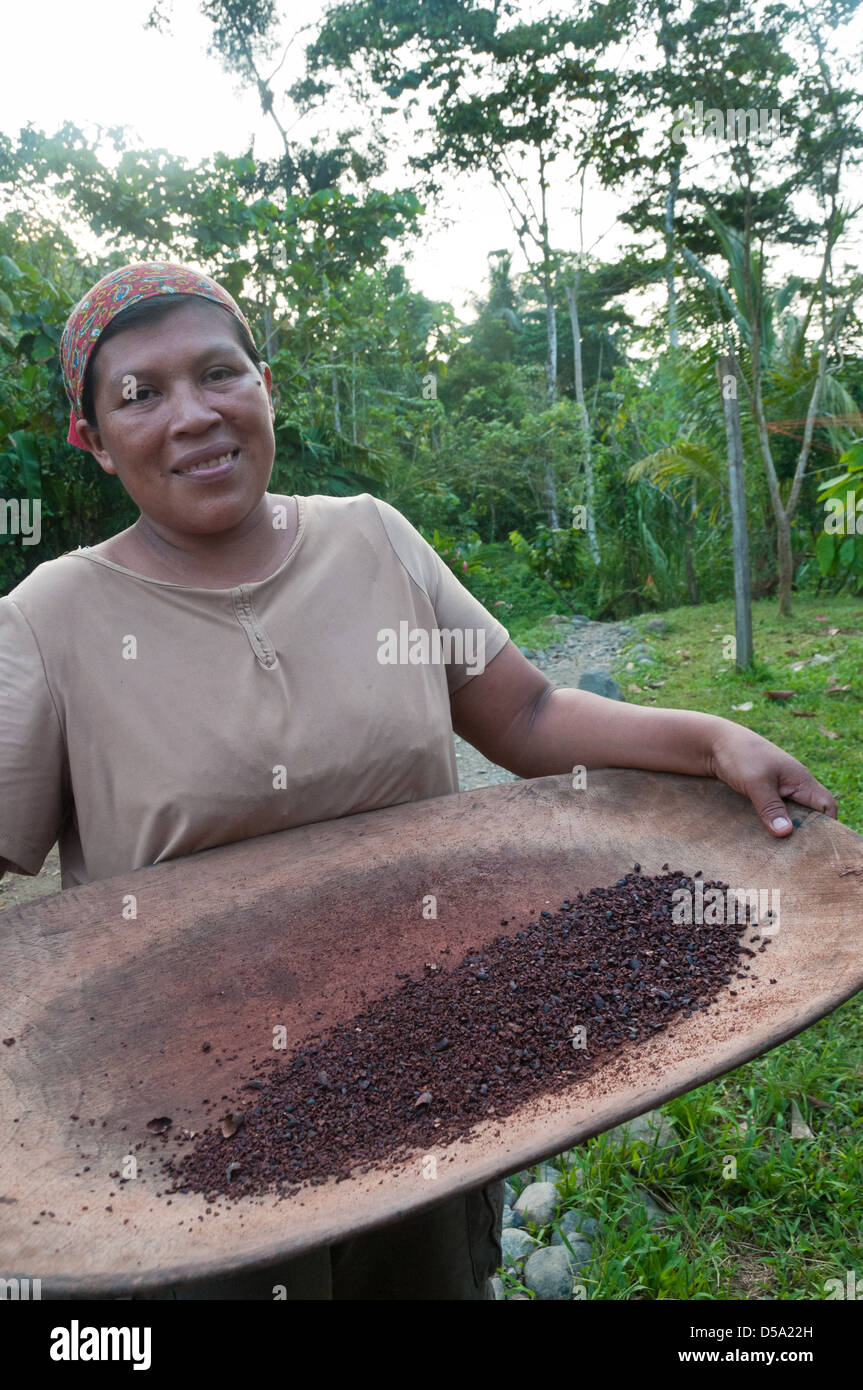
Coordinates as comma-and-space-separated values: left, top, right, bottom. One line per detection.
0, 492, 509, 888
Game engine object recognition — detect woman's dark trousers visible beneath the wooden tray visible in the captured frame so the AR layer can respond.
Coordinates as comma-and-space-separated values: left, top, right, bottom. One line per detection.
130, 1182, 503, 1301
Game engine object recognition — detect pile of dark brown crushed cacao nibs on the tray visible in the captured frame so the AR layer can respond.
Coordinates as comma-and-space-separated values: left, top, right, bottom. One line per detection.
165, 865, 774, 1200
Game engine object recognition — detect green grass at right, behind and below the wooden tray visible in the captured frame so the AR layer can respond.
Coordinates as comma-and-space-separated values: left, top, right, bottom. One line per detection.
504, 596, 863, 1301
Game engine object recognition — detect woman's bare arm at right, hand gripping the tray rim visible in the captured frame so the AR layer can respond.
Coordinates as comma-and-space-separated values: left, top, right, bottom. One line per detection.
450, 642, 837, 838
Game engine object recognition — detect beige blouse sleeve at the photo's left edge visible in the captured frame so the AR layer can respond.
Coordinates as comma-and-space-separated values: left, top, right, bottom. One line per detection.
0, 598, 65, 874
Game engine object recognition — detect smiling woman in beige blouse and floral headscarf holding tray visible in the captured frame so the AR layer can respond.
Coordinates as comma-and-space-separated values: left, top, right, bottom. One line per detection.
0, 263, 837, 1298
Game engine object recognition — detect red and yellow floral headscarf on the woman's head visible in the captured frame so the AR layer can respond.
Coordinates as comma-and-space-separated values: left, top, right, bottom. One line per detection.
60, 261, 254, 449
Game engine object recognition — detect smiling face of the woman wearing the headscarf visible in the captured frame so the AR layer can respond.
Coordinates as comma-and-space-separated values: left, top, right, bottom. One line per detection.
78, 296, 275, 535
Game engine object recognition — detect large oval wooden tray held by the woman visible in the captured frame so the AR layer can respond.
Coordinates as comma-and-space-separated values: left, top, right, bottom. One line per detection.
0, 770, 863, 1298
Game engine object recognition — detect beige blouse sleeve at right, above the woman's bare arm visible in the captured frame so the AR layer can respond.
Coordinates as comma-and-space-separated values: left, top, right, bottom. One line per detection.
374, 498, 510, 695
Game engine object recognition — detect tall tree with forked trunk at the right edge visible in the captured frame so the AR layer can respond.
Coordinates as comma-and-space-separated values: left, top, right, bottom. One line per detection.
600, 0, 863, 614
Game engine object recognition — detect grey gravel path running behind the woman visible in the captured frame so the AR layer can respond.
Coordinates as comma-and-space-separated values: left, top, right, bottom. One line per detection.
0, 619, 632, 912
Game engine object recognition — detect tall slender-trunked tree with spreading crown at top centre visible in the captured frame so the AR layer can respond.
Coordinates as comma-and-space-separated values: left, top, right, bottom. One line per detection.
306, 0, 636, 530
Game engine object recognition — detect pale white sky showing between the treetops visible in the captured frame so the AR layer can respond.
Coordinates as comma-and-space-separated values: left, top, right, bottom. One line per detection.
0, 0, 863, 328
